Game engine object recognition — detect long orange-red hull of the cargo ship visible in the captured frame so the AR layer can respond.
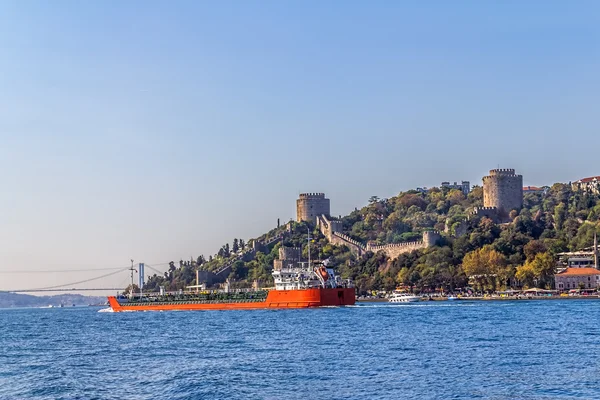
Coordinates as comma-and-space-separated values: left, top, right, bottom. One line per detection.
108, 288, 356, 312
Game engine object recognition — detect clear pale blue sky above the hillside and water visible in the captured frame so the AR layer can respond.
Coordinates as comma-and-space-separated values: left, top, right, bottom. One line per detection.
0, 0, 600, 289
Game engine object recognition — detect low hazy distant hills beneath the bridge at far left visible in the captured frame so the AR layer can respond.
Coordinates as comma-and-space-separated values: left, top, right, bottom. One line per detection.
0, 292, 106, 308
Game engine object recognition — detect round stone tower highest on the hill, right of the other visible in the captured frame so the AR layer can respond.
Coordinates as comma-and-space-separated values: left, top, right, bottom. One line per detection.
483, 169, 523, 220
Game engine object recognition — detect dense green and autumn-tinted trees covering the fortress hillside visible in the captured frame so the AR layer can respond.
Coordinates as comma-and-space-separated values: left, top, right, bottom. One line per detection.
138, 183, 600, 293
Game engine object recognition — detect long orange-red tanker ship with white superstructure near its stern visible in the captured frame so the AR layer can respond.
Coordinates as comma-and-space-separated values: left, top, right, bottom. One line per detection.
108, 262, 356, 312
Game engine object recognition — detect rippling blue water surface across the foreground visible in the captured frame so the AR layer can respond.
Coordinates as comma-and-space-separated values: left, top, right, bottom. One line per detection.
0, 300, 600, 399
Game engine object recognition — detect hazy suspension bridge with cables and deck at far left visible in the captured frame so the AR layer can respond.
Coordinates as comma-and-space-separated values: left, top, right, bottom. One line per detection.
0, 260, 169, 293
